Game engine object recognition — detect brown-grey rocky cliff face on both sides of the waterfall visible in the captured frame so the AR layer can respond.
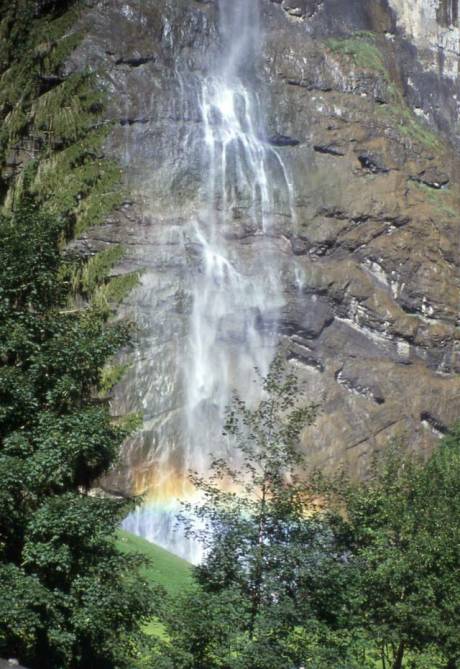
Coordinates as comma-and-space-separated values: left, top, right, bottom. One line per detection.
68, 0, 460, 490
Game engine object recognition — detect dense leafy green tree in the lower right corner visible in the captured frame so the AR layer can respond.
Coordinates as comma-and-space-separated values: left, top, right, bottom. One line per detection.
324, 434, 460, 669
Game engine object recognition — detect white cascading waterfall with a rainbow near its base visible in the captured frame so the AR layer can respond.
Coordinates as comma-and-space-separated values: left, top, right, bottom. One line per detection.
125, 0, 292, 562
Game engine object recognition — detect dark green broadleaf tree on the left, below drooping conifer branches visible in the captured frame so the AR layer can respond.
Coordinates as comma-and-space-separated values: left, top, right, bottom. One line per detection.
0, 198, 155, 669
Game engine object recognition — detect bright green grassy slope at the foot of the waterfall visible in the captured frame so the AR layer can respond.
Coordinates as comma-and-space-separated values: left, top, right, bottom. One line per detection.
117, 530, 193, 595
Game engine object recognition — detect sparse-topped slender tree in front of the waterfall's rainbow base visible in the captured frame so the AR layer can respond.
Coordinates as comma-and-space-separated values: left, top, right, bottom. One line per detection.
155, 358, 364, 669
